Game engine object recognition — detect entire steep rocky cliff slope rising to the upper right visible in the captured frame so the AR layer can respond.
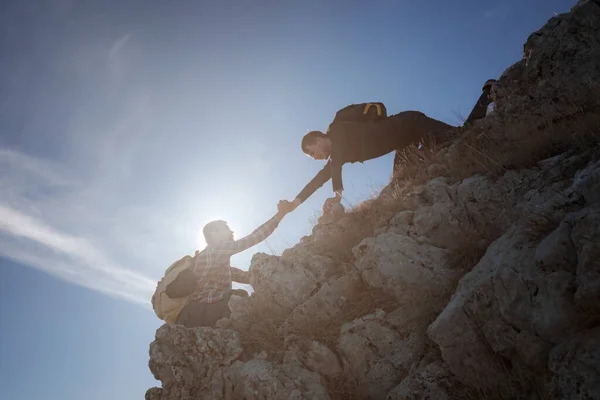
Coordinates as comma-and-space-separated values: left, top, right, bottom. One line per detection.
146, 1, 600, 400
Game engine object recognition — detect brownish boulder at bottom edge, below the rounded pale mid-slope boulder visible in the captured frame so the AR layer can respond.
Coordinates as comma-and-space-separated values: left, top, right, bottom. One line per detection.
338, 310, 424, 399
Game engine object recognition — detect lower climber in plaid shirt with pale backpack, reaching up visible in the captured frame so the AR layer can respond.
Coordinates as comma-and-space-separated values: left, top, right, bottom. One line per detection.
152, 201, 292, 328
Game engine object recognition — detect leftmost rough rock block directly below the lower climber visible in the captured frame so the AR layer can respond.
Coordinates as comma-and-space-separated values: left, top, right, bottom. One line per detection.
147, 324, 243, 400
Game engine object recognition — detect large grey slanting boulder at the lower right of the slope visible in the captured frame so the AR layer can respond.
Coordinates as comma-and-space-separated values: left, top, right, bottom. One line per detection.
429, 189, 600, 396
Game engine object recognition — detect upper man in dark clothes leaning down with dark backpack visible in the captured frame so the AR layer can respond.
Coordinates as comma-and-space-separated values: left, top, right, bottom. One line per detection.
284, 79, 496, 211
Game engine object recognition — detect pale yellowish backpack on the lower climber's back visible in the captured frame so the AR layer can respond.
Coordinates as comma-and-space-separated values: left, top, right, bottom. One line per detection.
152, 256, 194, 324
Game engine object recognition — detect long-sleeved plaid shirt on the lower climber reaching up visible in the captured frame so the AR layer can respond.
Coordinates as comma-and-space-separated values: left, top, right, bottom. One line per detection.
189, 216, 280, 303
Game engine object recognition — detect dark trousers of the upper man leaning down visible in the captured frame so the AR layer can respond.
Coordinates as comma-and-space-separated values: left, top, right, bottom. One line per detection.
389, 111, 460, 174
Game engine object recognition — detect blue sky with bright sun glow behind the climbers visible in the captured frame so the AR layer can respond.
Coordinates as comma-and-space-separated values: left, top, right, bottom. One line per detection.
0, 0, 574, 400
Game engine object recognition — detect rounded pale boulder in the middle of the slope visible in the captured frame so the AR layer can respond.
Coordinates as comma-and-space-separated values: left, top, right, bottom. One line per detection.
352, 233, 460, 312
